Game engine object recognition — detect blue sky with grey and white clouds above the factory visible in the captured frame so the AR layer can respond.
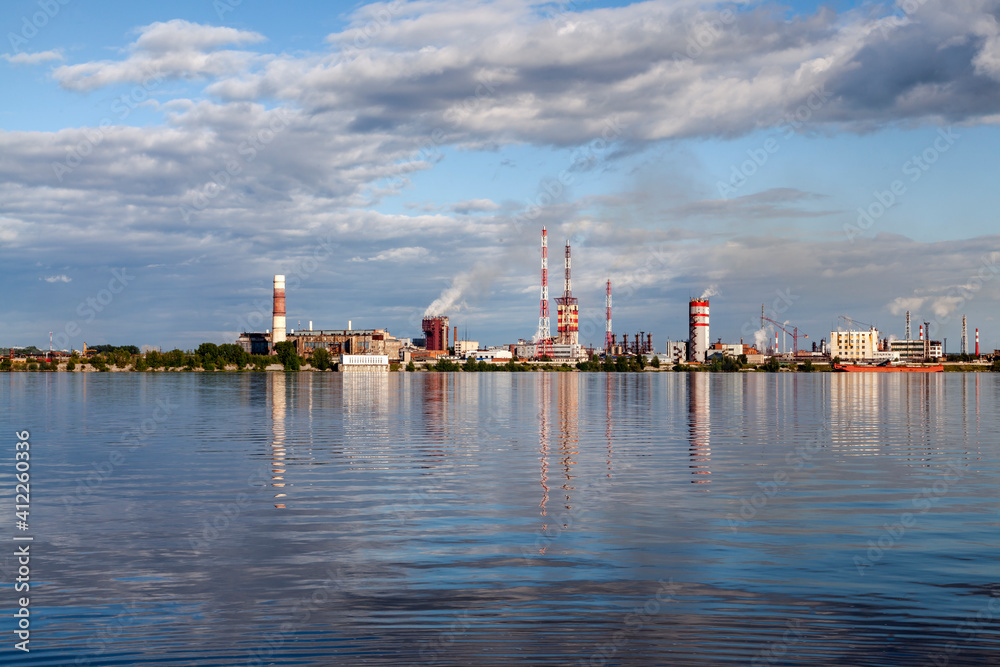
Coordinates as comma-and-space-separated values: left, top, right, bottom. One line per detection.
0, 0, 1000, 352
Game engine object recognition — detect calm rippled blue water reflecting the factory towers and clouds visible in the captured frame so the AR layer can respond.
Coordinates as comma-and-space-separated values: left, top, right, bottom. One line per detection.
0, 373, 1000, 666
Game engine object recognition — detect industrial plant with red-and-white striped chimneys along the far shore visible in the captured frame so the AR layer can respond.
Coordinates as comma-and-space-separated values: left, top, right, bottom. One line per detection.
221, 227, 992, 372
